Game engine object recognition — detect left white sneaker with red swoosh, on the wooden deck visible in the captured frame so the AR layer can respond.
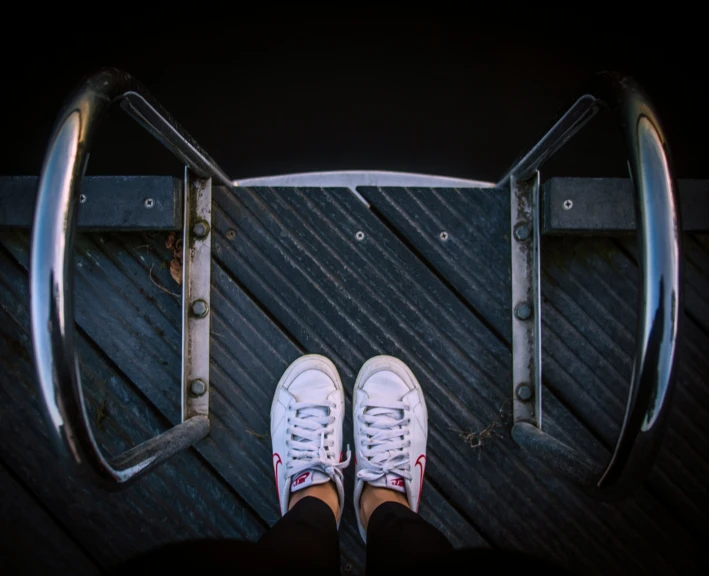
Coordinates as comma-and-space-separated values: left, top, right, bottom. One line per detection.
271, 354, 350, 526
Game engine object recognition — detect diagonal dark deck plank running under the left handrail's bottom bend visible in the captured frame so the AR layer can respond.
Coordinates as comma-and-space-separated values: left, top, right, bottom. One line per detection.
0, 250, 264, 569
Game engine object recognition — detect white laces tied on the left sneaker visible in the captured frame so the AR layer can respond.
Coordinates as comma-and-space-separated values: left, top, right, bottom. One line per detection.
286, 402, 351, 478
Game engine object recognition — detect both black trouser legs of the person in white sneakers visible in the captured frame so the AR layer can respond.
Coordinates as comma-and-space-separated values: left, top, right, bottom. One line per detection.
115, 498, 567, 576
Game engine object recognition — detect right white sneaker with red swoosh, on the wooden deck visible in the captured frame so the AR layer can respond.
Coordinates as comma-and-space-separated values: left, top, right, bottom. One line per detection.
352, 356, 428, 542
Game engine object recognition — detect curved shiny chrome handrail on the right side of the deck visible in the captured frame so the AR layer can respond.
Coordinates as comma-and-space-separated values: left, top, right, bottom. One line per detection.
503, 73, 682, 497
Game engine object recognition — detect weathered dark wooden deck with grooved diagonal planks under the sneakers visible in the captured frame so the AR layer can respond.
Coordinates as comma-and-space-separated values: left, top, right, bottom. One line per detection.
0, 187, 709, 574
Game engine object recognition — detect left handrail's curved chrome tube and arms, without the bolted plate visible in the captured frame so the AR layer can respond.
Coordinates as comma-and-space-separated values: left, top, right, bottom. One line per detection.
30, 70, 232, 486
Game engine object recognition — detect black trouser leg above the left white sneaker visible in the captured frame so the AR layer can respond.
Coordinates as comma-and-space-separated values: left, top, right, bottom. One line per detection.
112, 498, 340, 576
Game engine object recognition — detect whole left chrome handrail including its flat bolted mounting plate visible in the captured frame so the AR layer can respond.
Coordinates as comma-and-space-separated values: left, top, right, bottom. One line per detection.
30, 69, 232, 487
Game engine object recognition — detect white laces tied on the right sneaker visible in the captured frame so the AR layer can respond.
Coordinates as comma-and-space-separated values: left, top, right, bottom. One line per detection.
357, 400, 411, 482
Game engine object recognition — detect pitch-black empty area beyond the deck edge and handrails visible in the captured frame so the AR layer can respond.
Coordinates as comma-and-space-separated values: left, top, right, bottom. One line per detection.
0, 20, 709, 180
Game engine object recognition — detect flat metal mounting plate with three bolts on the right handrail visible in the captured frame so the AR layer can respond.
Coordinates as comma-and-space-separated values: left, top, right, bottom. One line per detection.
510, 174, 542, 428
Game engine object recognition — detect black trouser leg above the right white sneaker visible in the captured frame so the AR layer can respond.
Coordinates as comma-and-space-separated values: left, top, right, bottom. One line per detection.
367, 502, 453, 576
